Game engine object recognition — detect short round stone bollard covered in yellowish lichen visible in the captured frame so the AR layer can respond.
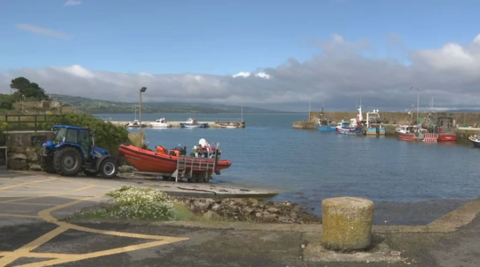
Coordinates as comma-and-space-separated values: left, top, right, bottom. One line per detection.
322, 197, 373, 251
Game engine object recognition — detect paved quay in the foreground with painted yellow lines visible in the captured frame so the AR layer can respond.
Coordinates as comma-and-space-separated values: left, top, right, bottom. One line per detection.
0, 172, 480, 267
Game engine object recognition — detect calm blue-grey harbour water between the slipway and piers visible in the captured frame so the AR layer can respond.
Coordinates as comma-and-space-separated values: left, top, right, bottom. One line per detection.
97, 114, 480, 218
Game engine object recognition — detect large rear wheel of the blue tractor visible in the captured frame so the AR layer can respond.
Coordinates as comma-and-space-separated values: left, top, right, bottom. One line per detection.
53, 147, 82, 176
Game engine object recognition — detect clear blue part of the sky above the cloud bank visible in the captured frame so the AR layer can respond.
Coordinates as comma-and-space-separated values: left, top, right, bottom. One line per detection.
0, 0, 480, 75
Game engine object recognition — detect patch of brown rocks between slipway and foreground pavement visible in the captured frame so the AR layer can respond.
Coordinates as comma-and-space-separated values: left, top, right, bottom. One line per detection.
172, 197, 321, 224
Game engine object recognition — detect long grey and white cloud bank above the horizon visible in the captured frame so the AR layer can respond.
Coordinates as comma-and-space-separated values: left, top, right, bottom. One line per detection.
0, 35, 480, 111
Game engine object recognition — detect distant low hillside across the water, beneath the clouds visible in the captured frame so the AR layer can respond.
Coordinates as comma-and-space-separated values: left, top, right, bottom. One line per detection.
50, 94, 279, 114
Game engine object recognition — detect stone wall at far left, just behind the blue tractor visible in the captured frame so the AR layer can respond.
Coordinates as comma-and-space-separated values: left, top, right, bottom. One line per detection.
5, 131, 53, 171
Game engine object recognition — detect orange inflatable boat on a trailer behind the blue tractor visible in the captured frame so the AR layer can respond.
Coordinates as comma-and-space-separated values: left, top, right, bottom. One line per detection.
120, 144, 231, 175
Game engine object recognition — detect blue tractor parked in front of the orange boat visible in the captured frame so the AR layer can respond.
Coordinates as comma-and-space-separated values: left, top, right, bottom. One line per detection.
40, 125, 118, 178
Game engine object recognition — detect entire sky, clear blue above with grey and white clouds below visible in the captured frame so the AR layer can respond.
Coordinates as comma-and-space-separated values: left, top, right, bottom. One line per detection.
0, 0, 480, 111
